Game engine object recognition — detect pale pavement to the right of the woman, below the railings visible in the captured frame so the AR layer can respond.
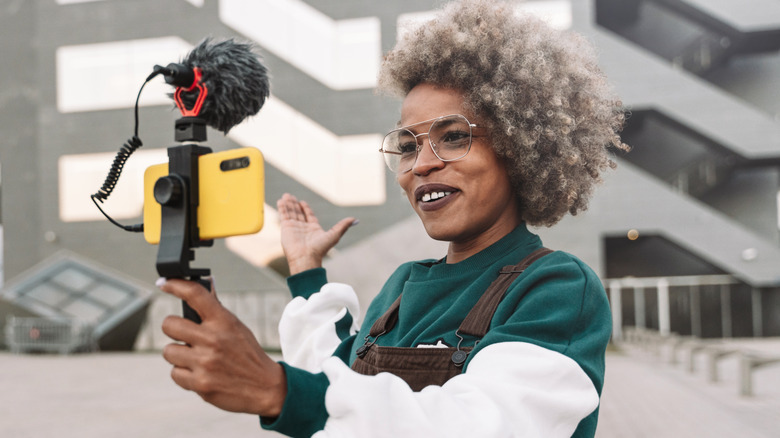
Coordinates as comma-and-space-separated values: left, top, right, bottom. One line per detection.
596, 340, 780, 438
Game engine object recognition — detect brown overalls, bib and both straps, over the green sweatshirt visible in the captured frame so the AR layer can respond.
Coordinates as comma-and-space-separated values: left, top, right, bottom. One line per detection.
352, 248, 552, 391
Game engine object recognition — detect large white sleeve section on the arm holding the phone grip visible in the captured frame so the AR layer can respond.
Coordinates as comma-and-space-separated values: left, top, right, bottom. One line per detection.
314, 342, 599, 438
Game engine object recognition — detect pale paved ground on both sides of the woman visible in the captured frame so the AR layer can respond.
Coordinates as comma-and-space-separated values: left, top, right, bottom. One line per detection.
0, 339, 780, 438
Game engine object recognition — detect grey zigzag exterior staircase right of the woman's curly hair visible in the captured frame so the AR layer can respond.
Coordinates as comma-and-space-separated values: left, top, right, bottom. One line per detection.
539, 0, 780, 326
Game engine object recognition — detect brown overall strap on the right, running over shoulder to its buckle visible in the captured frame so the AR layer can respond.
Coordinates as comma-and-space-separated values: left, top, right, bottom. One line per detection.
458, 248, 553, 339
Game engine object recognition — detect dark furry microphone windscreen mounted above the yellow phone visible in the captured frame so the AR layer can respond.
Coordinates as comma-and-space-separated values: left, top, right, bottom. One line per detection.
181, 37, 270, 134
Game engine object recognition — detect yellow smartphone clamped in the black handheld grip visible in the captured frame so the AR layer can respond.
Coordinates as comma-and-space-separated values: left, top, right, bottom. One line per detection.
144, 147, 265, 245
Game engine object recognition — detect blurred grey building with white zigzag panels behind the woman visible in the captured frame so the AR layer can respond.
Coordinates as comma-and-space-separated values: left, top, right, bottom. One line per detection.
0, 0, 780, 349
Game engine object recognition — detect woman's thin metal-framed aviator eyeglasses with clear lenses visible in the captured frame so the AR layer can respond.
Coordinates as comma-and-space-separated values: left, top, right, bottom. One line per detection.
379, 114, 477, 173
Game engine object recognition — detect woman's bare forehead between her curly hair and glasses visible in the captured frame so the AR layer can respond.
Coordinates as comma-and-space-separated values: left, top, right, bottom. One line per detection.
399, 84, 470, 126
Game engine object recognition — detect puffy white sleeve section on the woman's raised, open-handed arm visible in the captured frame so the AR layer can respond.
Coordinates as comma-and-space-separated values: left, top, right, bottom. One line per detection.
279, 283, 360, 373
